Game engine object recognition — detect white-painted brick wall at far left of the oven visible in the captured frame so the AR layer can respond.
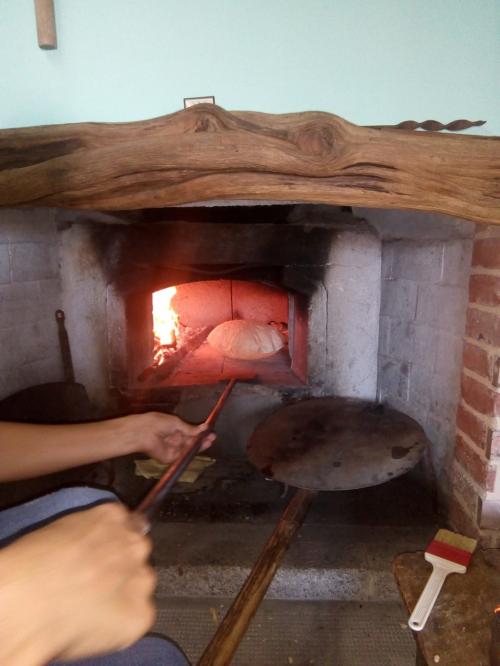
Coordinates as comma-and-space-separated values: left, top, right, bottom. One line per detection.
0, 209, 62, 399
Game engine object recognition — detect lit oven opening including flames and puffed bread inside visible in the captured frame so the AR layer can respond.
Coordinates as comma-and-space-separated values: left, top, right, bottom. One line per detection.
131, 280, 307, 386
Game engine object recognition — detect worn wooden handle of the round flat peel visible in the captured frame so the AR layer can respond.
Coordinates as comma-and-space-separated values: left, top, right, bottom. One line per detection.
198, 490, 316, 666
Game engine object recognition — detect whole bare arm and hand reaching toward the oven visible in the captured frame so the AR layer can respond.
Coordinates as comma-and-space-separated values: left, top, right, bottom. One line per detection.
0, 412, 214, 481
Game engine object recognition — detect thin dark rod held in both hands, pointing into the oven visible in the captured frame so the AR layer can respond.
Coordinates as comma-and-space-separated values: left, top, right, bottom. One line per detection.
134, 379, 237, 518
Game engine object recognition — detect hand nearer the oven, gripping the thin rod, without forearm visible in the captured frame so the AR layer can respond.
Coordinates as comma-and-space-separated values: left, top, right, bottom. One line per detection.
117, 412, 215, 463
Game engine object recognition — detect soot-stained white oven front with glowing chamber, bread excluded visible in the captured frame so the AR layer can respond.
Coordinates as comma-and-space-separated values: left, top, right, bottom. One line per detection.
70, 206, 381, 398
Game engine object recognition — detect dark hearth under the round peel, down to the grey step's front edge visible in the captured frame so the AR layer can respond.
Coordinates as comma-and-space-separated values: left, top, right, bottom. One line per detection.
112, 459, 437, 602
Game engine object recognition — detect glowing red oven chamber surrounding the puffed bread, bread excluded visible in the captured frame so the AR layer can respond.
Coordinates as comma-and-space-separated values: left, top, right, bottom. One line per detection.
126, 279, 307, 388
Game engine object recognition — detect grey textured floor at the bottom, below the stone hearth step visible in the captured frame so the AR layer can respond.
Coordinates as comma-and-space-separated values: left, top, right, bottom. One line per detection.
156, 598, 415, 666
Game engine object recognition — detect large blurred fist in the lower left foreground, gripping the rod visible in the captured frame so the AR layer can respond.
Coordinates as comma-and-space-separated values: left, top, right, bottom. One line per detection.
0, 503, 156, 666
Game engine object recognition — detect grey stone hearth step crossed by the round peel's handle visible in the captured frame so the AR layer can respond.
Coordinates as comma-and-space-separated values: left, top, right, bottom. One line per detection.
153, 523, 435, 601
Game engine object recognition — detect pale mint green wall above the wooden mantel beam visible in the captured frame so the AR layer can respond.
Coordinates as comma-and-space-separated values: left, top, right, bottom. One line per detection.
0, 0, 500, 135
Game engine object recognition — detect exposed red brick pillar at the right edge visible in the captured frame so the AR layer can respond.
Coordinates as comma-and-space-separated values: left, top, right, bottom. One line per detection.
450, 226, 500, 547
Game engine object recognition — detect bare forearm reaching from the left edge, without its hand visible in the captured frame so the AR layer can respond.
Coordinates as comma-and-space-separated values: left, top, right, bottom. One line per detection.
0, 419, 132, 481
